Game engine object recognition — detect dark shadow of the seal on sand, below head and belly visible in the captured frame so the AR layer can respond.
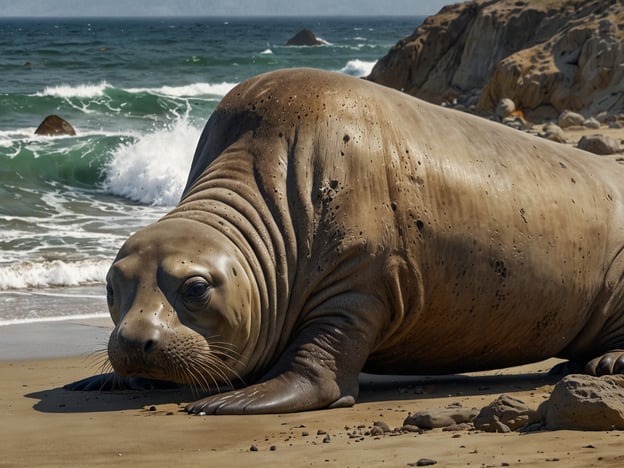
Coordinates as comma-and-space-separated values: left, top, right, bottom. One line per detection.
24, 373, 561, 413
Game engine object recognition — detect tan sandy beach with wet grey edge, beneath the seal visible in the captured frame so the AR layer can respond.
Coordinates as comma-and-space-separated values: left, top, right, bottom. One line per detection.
0, 312, 624, 467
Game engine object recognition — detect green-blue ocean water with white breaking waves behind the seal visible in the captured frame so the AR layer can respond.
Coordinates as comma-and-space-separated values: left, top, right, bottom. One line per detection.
0, 17, 423, 325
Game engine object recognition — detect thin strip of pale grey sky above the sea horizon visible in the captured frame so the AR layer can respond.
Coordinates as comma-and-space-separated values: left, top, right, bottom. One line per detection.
0, 0, 459, 18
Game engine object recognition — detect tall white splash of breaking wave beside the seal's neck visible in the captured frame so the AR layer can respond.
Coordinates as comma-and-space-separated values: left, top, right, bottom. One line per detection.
105, 117, 201, 206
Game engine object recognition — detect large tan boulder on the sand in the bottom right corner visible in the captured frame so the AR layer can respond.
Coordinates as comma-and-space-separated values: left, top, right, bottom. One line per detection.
538, 374, 624, 431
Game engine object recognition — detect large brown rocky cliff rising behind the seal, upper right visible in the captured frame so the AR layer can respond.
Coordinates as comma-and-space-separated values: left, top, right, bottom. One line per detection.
368, 0, 624, 120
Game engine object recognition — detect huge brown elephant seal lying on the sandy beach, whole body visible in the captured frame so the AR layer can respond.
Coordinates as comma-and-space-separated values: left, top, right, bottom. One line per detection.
66, 69, 624, 414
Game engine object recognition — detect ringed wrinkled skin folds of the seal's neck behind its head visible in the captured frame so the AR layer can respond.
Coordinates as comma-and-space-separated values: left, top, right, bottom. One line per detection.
165, 136, 296, 383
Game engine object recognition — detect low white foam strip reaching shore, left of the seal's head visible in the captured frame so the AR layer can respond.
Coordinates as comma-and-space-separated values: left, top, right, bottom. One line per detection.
0, 260, 110, 290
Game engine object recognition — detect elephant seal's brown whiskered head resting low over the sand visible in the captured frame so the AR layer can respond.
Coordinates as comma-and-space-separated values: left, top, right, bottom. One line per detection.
107, 219, 256, 389
